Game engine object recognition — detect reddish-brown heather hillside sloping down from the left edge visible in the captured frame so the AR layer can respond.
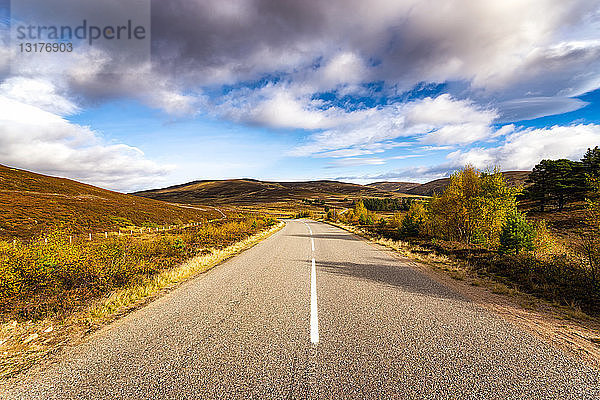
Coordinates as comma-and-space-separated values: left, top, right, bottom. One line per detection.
0, 165, 220, 239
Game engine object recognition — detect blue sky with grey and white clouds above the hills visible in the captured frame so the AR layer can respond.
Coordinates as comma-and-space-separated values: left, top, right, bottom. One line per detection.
0, 0, 600, 192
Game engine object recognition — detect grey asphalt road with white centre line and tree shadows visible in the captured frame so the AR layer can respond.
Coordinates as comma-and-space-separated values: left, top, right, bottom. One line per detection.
5, 221, 600, 400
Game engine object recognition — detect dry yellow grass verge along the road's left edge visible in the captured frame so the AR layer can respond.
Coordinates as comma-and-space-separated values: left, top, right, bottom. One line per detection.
0, 219, 284, 382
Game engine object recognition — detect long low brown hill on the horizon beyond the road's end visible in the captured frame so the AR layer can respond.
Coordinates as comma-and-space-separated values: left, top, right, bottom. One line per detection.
134, 179, 403, 205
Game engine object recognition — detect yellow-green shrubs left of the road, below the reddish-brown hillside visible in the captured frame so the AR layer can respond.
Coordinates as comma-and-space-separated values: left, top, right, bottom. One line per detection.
0, 216, 277, 321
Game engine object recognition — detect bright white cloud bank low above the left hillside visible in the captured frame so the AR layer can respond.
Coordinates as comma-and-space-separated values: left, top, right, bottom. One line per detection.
0, 96, 171, 191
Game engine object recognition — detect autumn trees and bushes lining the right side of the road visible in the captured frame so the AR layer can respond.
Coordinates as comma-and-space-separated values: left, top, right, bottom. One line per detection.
326, 147, 600, 315
